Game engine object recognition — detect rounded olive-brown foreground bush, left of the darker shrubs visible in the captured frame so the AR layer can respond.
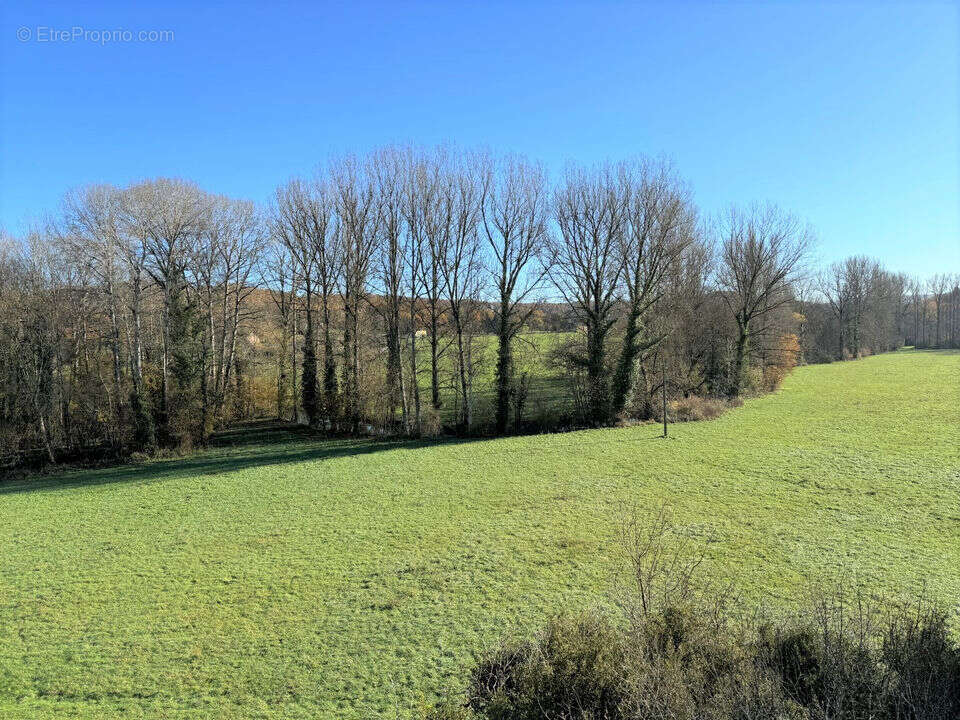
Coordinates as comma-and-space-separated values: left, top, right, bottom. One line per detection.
436, 608, 803, 720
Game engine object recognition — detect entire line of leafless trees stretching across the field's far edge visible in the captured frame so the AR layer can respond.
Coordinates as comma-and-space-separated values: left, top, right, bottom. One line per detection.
0, 147, 960, 465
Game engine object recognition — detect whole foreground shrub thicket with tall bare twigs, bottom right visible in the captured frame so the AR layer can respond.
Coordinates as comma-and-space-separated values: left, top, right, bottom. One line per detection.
428, 510, 960, 720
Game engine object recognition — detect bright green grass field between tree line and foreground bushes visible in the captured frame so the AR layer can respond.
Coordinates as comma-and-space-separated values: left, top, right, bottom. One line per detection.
0, 351, 960, 719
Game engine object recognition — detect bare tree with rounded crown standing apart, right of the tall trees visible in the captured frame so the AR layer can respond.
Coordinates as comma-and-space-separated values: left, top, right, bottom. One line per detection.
717, 205, 812, 396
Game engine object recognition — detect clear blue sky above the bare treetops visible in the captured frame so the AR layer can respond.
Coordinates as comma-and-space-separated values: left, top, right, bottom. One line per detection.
0, 2, 960, 274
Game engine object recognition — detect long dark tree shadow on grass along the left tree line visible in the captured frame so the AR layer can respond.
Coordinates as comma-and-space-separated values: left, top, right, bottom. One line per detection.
0, 421, 480, 495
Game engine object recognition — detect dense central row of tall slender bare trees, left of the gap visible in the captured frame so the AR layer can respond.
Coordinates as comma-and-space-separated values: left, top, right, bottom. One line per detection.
267, 148, 550, 434
